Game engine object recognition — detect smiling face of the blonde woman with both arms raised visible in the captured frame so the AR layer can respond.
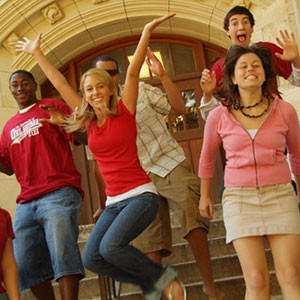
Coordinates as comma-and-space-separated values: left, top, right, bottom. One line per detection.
83, 74, 113, 110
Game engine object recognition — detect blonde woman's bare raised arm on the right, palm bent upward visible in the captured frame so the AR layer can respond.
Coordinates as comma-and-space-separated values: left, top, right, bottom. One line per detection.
122, 14, 175, 113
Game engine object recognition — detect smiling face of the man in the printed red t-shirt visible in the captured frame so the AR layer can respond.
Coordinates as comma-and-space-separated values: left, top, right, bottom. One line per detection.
9, 73, 37, 109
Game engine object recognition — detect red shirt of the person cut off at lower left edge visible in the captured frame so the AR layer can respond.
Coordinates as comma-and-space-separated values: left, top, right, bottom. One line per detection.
0, 208, 15, 294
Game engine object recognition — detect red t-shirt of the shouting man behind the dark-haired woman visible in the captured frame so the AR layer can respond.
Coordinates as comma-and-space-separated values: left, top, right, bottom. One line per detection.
211, 42, 292, 87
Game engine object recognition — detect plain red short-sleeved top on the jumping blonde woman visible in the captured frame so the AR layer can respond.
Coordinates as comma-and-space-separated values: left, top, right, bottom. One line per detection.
88, 100, 151, 196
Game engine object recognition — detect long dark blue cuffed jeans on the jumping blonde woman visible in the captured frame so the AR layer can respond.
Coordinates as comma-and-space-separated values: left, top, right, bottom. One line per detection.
82, 192, 177, 299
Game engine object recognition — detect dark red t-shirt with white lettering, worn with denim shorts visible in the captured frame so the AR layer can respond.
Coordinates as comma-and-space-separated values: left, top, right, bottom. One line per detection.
0, 99, 83, 203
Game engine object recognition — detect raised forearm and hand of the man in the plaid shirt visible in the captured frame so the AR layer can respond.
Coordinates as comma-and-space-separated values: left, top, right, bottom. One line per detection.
146, 47, 185, 115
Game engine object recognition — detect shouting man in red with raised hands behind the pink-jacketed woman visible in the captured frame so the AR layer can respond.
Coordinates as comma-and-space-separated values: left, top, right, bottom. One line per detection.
199, 6, 300, 120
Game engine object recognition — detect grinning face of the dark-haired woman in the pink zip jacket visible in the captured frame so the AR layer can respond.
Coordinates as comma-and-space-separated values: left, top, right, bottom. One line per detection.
232, 53, 266, 89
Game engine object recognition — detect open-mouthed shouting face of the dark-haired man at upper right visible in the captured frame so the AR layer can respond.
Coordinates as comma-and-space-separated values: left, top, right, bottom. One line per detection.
226, 14, 253, 47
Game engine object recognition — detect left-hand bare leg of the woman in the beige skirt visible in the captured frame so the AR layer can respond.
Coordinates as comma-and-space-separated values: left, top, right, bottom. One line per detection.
233, 236, 270, 300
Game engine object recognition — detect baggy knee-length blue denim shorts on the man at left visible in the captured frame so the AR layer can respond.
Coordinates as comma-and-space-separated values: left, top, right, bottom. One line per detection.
13, 186, 84, 290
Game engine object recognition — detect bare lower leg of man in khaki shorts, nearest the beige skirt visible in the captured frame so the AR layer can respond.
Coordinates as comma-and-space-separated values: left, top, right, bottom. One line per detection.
186, 228, 223, 299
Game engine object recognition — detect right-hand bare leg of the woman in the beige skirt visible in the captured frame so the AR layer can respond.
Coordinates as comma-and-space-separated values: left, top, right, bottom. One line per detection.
268, 235, 300, 300
